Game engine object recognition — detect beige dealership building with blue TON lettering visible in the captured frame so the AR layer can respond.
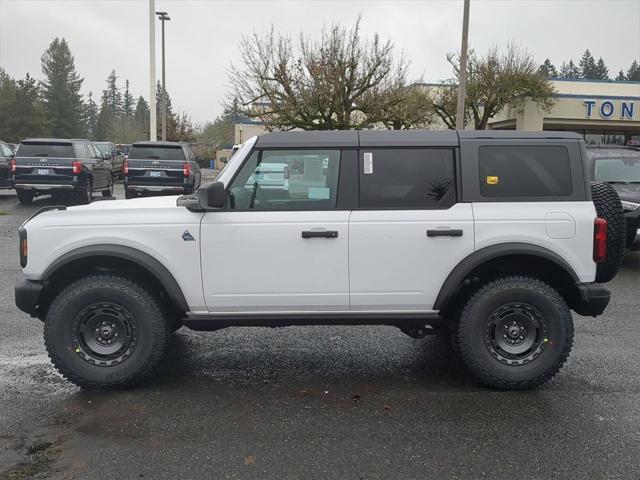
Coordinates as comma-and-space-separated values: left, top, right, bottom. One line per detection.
488, 80, 640, 145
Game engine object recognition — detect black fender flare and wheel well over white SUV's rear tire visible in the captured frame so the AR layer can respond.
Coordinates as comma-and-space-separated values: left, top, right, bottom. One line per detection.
433, 242, 580, 313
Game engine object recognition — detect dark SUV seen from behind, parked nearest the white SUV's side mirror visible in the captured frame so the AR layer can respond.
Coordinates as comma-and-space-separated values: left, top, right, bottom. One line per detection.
123, 142, 201, 198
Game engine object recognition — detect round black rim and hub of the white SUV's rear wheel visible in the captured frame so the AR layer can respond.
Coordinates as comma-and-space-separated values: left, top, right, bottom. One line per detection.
485, 302, 548, 365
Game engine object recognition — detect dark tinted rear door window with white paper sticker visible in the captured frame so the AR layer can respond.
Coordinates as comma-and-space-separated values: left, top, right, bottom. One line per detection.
360, 148, 456, 209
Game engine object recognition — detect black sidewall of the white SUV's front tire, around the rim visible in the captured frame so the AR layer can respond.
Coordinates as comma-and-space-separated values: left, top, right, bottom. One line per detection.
45, 278, 164, 386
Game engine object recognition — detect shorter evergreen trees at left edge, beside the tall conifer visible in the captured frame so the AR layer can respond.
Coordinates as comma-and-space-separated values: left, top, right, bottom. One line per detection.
0, 68, 49, 143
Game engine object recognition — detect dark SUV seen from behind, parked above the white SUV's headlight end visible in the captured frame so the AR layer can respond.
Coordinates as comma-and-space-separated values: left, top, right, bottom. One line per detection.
13, 138, 113, 203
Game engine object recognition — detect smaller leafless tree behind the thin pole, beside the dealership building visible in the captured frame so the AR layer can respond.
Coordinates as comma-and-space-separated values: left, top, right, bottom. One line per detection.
433, 42, 555, 130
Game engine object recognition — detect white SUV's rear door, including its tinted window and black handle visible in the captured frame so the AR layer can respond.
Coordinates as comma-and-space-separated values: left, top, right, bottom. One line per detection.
349, 147, 474, 312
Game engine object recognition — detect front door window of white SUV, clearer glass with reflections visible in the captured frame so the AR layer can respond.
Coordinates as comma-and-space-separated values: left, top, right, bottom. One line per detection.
229, 150, 340, 210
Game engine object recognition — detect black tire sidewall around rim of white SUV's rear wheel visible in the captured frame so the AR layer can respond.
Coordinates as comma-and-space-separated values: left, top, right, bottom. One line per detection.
458, 285, 573, 386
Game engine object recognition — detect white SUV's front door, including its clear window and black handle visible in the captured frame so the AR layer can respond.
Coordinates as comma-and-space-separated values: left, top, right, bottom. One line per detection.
201, 150, 350, 312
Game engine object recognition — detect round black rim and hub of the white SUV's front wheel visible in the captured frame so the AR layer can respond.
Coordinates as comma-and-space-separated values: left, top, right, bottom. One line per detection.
71, 302, 137, 367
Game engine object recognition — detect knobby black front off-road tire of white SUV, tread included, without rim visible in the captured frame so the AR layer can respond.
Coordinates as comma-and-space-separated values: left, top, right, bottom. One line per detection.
44, 274, 169, 389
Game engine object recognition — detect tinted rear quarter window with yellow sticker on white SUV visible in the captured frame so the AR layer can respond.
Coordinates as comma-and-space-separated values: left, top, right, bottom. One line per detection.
478, 145, 573, 197
